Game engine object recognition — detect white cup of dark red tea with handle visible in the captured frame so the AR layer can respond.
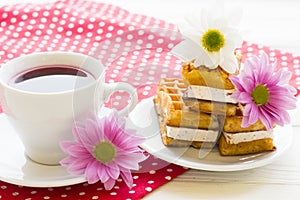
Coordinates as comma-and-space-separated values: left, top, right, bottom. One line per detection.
0, 52, 137, 165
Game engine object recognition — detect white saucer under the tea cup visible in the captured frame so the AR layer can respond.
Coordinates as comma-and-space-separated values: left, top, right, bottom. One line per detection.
0, 114, 85, 187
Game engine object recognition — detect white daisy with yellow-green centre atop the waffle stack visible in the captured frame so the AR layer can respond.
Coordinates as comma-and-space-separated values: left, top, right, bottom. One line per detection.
179, 5, 242, 74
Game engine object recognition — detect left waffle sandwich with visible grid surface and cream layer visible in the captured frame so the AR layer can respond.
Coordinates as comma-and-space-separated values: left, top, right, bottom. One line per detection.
154, 78, 219, 148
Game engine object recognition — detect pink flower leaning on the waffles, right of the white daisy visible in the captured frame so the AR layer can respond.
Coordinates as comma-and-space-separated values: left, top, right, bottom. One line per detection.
230, 53, 297, 130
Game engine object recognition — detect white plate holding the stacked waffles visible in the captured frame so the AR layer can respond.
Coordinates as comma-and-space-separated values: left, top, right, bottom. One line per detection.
128, 98, 293, 171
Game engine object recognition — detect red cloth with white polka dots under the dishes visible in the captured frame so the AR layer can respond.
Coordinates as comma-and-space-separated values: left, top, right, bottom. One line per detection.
0, 0, 300, 200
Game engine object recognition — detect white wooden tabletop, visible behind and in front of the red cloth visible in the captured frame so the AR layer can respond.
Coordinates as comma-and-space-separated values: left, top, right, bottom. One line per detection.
0, 0, 300, 200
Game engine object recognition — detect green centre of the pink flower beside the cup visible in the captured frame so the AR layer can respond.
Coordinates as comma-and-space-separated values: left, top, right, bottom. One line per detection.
94, 141, 116, 163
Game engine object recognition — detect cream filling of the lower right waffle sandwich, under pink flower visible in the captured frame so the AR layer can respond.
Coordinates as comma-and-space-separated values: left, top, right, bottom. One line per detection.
223, 130, 273, 144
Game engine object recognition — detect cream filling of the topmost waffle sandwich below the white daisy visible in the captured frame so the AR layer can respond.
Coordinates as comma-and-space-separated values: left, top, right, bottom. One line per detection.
187, 85, 237, 103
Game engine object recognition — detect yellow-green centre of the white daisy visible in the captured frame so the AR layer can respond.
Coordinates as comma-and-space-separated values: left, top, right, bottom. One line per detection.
201, 29, 225, 52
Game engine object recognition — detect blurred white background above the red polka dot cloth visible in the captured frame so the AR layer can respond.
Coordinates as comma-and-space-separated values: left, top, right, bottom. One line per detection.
0, 0, 300, 55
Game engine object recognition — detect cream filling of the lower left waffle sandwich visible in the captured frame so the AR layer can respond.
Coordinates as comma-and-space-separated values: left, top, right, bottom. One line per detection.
166, 126, 219, 142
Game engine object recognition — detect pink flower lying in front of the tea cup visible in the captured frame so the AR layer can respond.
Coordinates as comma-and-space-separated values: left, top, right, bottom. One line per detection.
60, 111, 147, 190
